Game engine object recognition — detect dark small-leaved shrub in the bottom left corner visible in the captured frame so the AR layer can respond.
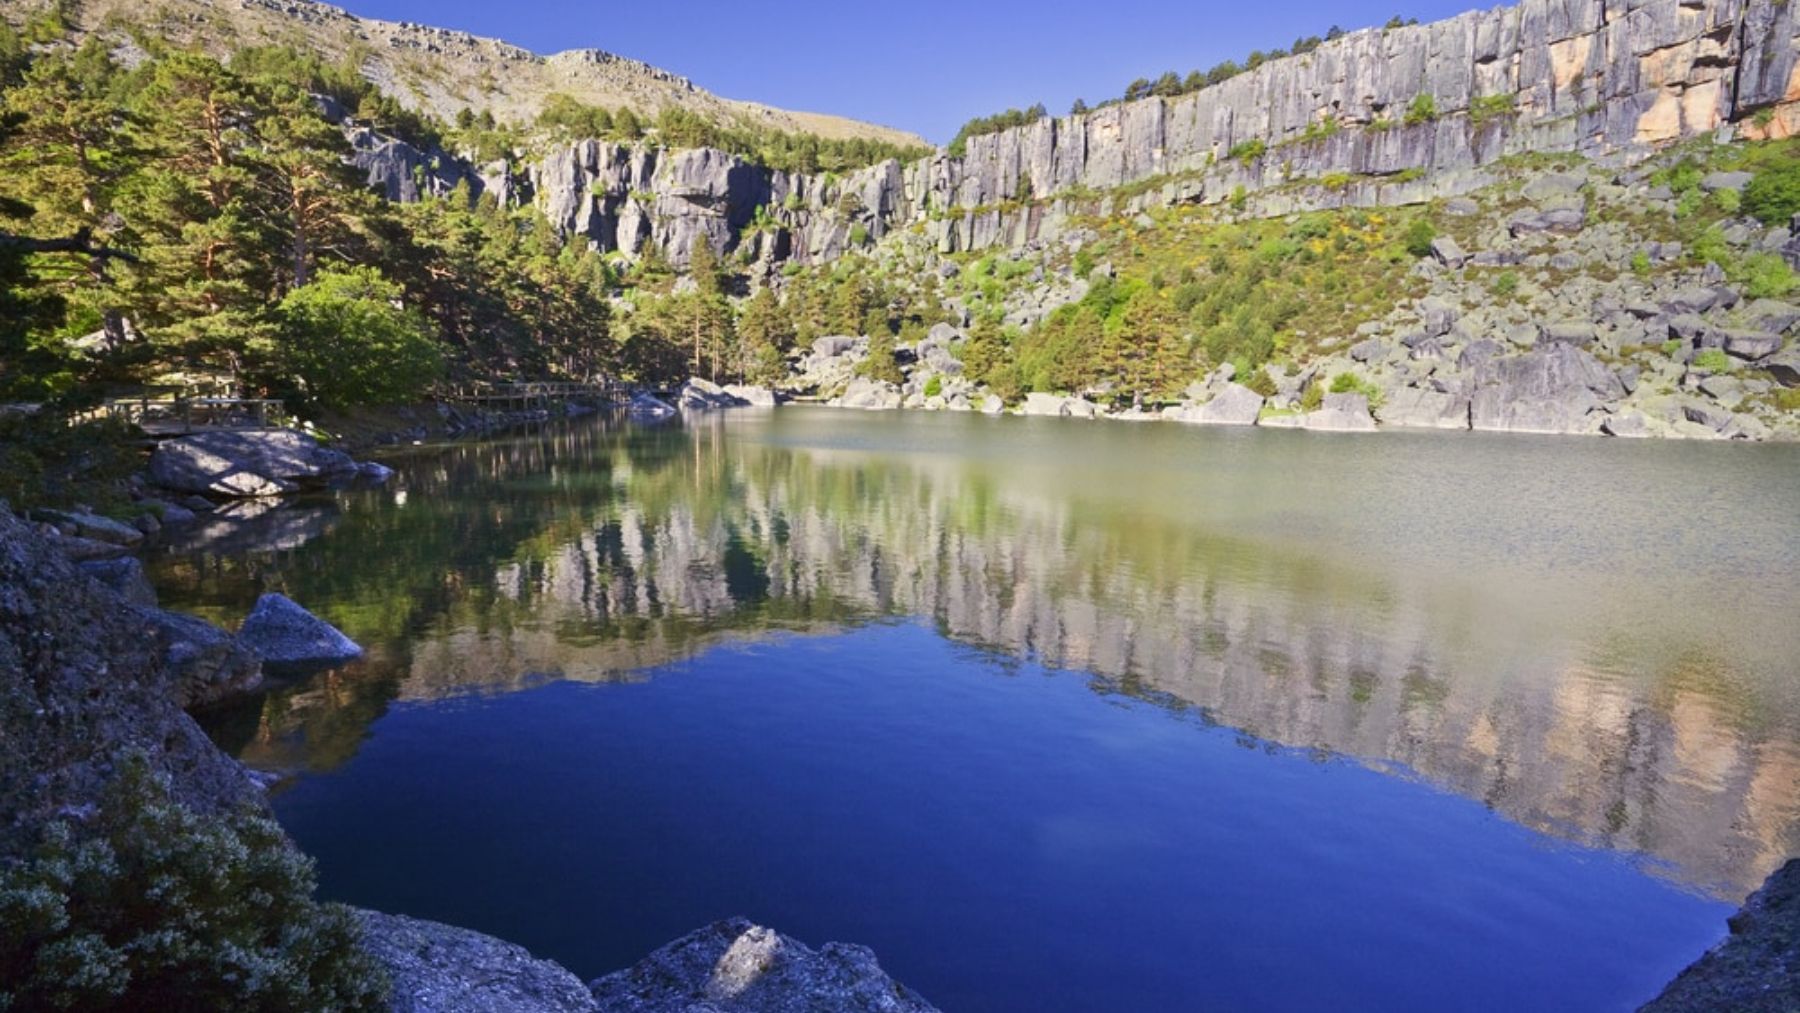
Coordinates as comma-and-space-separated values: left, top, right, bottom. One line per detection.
0, 758, 387, 1011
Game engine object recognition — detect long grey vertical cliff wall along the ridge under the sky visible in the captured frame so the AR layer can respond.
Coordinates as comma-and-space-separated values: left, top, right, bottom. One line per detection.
500, 0, 1800, 263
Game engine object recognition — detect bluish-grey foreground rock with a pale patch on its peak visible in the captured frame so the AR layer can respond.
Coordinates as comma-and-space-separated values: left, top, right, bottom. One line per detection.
592, 918, 936, 1013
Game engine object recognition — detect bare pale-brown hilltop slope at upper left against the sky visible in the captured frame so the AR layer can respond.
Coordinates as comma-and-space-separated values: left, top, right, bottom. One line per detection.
25, 0, 923, 144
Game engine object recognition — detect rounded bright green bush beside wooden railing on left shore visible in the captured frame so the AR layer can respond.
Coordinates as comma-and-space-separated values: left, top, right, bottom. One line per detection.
268, 268, 443, 408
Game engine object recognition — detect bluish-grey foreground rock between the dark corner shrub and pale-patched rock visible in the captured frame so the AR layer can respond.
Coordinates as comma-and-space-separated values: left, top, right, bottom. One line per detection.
356, 910, 599, 1013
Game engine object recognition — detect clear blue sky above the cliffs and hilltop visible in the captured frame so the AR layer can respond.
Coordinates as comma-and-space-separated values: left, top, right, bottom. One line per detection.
335, 0, 1492, 144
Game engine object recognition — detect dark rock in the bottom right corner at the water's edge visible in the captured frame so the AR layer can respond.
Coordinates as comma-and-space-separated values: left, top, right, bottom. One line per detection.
1643, 858, 1800, 1013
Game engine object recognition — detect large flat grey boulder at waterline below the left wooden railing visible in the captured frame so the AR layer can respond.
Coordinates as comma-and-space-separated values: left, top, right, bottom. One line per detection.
149, 430, 356, 498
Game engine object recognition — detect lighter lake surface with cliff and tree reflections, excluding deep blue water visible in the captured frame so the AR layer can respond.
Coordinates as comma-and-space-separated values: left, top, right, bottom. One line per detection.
155, 410, 1800, 896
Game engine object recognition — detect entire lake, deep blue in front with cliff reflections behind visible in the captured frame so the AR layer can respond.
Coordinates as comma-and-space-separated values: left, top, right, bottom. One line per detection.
151, 407, 1800, 1011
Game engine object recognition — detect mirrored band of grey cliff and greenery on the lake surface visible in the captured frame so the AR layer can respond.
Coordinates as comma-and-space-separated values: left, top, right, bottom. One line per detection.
162, 415, 1800, 891
